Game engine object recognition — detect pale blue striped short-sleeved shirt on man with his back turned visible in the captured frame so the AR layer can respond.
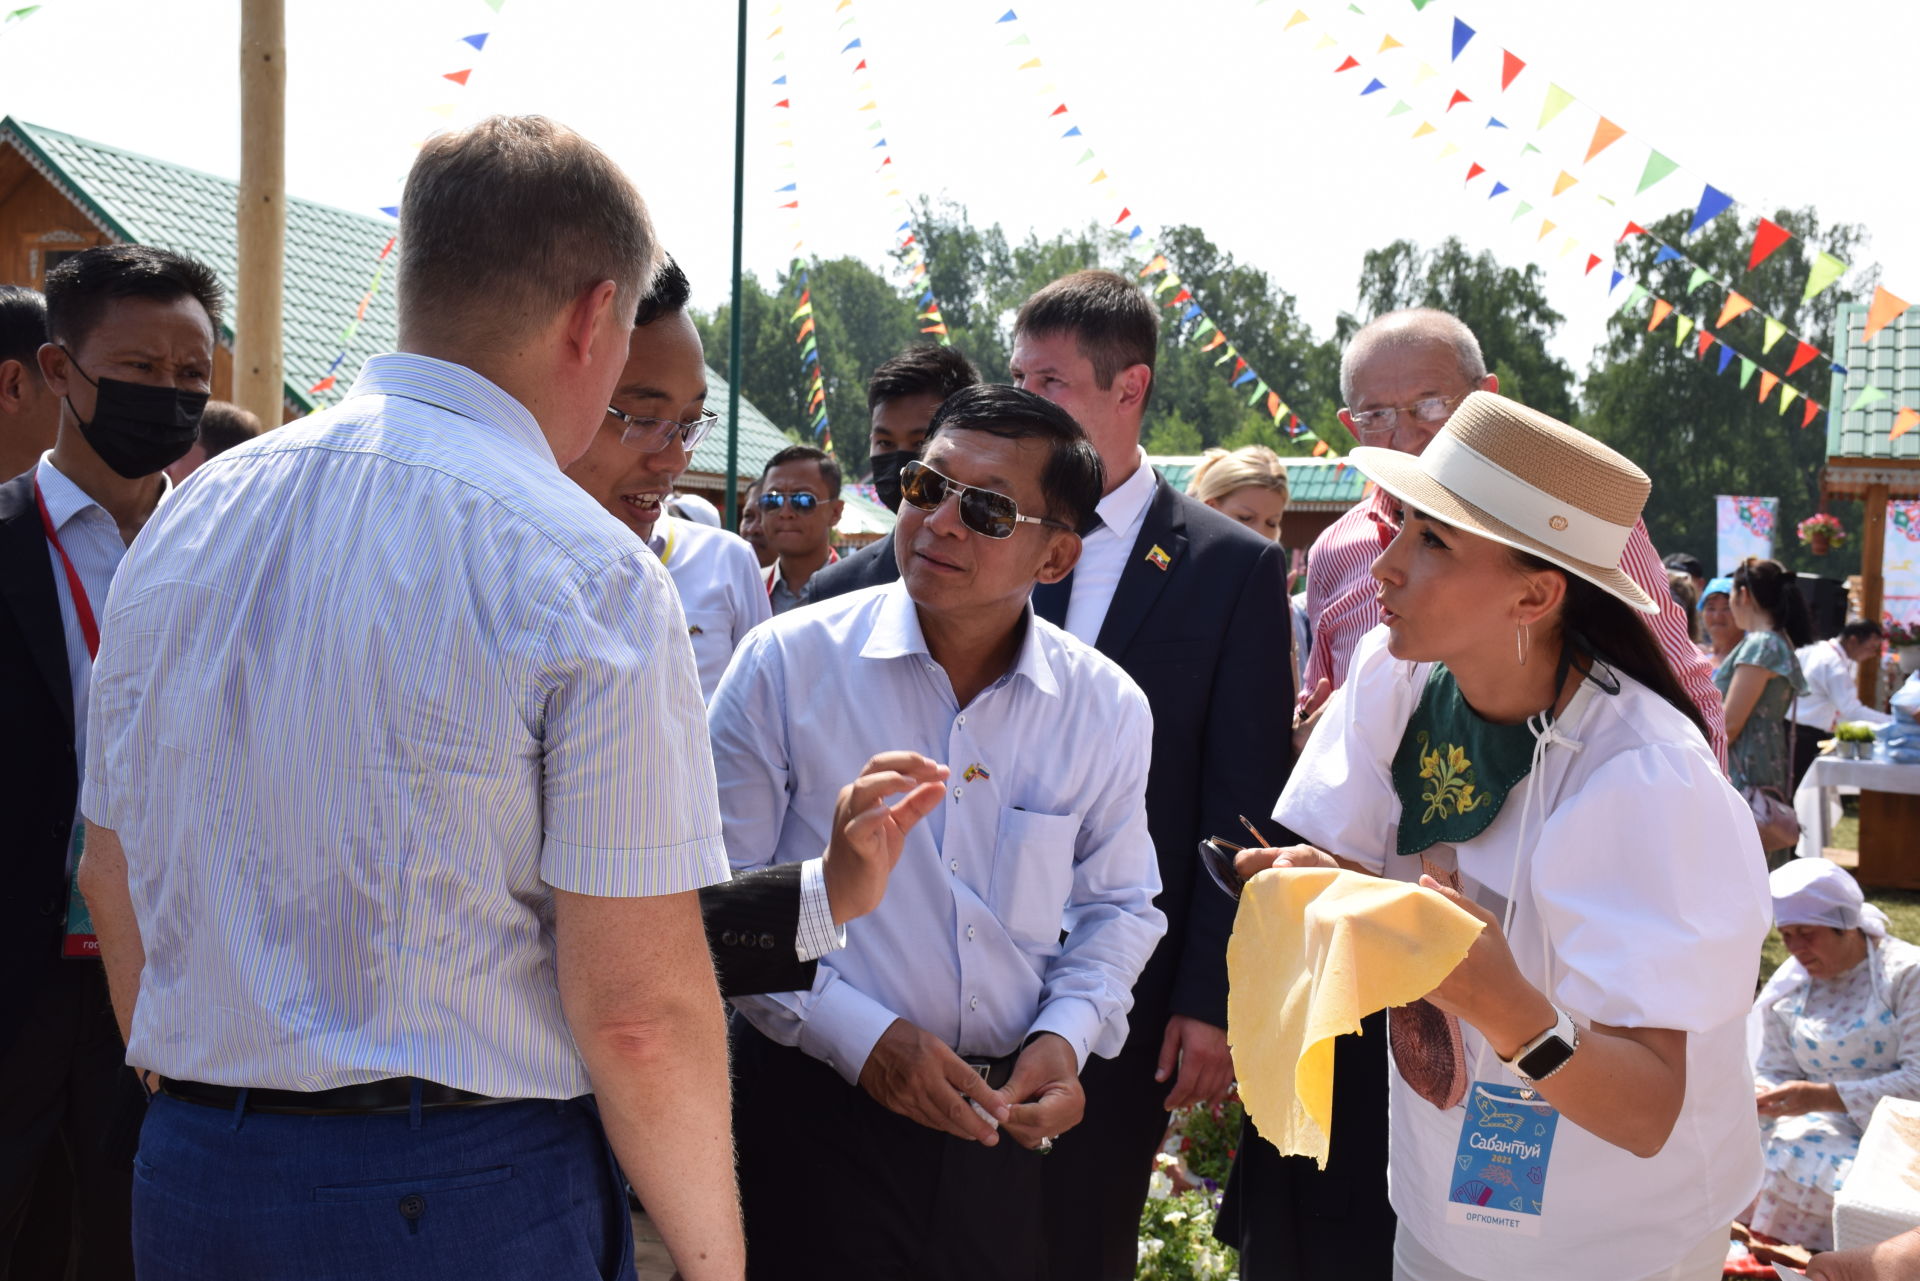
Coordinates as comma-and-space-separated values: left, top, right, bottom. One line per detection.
83, 355, 726, 1099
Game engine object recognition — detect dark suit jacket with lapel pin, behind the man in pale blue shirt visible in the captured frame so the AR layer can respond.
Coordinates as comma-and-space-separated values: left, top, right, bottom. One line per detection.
1098, 474, 1294, 1045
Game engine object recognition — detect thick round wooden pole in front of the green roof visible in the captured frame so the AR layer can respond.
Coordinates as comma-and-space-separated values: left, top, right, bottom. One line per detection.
234, 0, 286, 428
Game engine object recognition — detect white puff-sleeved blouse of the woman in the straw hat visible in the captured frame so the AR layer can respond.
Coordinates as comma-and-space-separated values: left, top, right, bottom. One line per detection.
1275, 626, 1772, 1277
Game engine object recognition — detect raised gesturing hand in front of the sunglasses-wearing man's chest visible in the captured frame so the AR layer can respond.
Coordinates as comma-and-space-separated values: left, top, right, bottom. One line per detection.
824, 751, 947, 926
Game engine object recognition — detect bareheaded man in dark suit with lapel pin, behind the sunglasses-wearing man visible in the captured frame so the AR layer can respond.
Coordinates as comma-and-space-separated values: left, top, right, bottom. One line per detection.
1012, 271, 1292, 1281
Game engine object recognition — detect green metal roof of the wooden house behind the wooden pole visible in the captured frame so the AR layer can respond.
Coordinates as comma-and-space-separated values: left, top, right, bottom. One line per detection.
0, 117, 797, 478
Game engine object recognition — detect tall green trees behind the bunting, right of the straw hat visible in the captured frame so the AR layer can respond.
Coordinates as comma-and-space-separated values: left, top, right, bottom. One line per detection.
1580, 209, 1864, 574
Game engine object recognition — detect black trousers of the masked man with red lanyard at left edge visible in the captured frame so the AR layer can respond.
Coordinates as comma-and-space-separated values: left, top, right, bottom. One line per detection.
0, 960, 146, 1281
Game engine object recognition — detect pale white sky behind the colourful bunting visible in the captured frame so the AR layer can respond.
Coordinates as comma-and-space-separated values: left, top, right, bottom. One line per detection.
0, 0, 1920, 391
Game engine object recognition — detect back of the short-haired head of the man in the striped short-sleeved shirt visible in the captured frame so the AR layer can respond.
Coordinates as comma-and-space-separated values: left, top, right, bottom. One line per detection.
397, 115, 659, 351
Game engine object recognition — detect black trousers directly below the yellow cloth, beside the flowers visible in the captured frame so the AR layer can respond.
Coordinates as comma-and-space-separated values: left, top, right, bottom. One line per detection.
1213, 1010, 1398, 1281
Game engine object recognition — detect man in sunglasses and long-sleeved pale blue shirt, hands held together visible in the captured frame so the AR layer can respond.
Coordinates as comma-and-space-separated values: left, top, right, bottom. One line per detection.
710, 386, 1165, 1281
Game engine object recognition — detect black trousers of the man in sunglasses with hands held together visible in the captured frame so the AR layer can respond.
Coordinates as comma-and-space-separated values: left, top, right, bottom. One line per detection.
732, 1018, 1052, 1281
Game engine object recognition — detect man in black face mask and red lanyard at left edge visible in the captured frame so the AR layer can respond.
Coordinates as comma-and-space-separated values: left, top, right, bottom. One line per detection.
0, 244, 225, 1277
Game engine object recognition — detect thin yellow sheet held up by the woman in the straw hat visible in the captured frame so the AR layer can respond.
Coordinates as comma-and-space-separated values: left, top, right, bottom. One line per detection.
1227, 868, 1480, 1170
